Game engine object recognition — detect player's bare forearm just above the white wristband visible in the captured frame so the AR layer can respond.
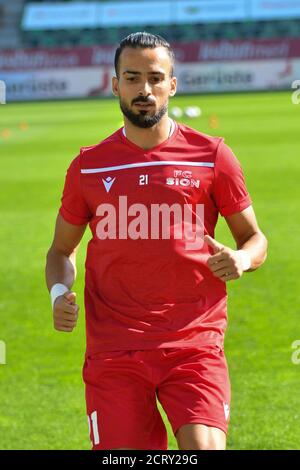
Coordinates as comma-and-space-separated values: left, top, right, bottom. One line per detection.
46, 247, 76, 292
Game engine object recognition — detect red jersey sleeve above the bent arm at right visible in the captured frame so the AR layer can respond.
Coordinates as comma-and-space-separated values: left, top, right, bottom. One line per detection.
214, 140, 252, 217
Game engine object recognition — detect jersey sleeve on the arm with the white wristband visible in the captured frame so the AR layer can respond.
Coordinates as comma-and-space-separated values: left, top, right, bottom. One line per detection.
59, 156, 92, 225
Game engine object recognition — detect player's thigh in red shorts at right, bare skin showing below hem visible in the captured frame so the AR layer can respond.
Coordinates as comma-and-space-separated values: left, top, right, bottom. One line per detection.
158, 345, 230, 447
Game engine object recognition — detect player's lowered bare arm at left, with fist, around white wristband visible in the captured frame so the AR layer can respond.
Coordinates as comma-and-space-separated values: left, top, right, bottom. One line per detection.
46, 215, 87, 332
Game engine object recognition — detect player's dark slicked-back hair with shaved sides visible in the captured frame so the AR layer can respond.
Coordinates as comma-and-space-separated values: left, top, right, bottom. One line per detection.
115, 31, 175, 77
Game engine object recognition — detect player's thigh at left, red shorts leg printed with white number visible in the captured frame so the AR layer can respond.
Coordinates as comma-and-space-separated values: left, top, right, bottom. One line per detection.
83, 351, 167, 450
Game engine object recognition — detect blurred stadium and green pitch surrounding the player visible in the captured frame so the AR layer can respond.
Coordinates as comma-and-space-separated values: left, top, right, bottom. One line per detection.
0, 0, 300, 449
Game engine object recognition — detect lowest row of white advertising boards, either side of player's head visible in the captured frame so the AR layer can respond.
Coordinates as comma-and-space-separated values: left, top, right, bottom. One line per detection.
0, 59, 300, 102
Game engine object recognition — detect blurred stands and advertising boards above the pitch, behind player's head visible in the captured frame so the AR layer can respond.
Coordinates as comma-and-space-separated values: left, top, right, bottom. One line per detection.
0, 0, 300, 101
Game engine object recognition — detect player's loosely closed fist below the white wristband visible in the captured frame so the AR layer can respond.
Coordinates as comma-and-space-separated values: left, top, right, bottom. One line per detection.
53, 292, 79, 333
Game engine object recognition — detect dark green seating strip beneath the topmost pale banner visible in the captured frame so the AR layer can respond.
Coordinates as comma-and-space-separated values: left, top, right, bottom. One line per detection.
0, 0, 300, 48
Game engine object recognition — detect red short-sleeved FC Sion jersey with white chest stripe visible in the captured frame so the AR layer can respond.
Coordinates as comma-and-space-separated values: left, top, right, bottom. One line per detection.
60, 123, 251, 354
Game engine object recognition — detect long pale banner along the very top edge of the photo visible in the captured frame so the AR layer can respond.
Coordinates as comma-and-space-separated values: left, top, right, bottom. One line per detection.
22, 0, 300, 30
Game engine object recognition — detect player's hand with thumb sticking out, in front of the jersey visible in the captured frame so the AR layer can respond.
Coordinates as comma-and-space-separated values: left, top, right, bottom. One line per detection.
204, 235, 244, 282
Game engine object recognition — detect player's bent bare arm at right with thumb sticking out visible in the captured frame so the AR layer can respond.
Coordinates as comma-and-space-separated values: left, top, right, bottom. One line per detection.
204, 206, 268, 282
